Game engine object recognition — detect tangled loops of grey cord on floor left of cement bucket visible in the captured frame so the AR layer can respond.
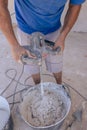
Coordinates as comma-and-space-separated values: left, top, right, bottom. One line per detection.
0, 65, 32, 110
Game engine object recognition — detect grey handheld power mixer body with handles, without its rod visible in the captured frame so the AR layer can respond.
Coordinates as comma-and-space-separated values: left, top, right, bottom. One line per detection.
21, 32, 61, 65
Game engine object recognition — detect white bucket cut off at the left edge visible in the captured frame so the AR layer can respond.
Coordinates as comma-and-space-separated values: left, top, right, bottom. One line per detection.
0, 96, 10, 130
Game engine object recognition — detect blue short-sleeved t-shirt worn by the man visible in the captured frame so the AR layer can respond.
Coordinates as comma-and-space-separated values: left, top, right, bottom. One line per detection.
15, 0, 85, 34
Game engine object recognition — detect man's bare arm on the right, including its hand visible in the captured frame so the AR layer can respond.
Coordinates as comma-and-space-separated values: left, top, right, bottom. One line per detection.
54, 4, 81, 50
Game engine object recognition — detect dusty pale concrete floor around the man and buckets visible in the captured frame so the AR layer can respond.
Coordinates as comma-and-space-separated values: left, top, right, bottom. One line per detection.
0, 29, 87, 130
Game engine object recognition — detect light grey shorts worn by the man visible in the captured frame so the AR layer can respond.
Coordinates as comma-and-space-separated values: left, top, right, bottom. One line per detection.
17, 28, 63, 75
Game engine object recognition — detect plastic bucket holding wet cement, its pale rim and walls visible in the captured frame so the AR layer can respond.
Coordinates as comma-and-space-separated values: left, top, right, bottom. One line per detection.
19, 82, 71, 130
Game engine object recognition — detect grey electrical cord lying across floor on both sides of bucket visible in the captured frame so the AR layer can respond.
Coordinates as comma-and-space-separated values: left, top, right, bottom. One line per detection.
0, 65, 87, 109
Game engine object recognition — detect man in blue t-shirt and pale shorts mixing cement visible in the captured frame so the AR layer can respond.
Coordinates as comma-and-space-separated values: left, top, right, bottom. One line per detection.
0, 0, 85, 84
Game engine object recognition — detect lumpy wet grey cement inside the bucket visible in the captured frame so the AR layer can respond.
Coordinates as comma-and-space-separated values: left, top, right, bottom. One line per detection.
20, 86, 67, 127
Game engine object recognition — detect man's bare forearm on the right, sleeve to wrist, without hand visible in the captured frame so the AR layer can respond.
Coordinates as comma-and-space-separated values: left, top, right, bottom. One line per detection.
60, 4, 81, 40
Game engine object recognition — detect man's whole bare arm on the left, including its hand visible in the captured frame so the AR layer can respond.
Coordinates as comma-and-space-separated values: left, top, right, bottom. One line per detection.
0, 0, 27, 61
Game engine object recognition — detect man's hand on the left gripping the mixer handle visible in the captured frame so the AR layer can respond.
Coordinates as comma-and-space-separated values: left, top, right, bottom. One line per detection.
11, 44, 29, 62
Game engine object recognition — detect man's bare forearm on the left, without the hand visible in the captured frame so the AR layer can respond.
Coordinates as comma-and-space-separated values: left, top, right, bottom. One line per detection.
0, 2, 18, 46
